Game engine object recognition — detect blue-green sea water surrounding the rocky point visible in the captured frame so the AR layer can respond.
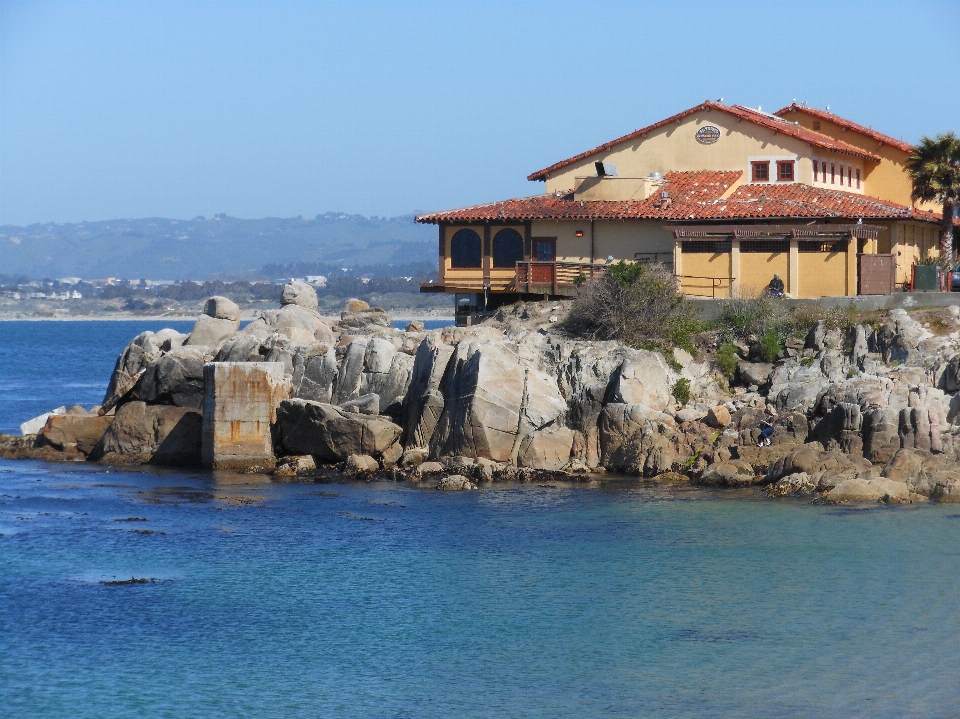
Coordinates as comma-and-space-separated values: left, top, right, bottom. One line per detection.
0, 322, 960, 717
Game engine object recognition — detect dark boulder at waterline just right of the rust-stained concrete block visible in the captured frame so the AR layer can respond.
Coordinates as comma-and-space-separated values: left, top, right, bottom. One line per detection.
277, 399, 402, 461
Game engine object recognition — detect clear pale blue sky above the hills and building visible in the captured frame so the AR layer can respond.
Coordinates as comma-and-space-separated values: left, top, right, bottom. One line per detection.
0, 0, 960, 225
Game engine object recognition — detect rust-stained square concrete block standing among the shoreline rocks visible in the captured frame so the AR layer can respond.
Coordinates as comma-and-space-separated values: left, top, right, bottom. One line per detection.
201, 362, 290, 469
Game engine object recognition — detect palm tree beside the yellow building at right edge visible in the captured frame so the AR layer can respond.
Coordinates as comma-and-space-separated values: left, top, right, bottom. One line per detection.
907, 132, 960, 262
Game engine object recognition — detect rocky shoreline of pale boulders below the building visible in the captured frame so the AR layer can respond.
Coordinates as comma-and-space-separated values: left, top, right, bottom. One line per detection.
0, 283, 960, 503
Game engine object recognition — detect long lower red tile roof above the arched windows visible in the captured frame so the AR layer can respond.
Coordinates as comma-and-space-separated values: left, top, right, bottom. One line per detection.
416, 171, 960, 224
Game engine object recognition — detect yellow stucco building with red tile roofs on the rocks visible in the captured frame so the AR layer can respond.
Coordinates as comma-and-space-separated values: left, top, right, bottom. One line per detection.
417, 102, 952, 308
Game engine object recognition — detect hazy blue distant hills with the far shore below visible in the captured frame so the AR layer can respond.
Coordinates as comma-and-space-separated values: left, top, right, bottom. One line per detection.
0, 212, 437, 280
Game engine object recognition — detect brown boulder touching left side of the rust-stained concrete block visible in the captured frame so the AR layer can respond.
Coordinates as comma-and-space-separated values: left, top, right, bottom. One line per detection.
90, 402, 201, 467
